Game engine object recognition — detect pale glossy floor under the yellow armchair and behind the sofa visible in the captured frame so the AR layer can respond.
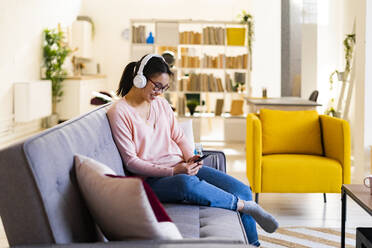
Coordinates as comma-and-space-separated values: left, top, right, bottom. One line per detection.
0, 142, 372, 247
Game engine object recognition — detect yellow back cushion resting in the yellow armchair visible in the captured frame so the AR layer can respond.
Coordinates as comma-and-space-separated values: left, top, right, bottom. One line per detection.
260, 109, 323, 155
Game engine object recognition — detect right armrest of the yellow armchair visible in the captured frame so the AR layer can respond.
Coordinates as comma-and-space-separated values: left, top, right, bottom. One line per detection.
320, 115, 351, 184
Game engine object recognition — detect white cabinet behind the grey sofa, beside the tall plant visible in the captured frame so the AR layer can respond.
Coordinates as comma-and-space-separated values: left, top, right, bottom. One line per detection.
57, 76, 105, 120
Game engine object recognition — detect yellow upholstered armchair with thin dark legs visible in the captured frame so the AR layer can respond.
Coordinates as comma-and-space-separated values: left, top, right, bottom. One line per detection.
246, 110, 350, 202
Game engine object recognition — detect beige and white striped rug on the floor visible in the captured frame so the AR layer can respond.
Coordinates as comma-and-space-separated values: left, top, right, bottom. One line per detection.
258, 227, 355, 248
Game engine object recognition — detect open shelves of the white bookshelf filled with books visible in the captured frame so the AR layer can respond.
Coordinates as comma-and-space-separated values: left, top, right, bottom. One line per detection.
130, 19, 251, 118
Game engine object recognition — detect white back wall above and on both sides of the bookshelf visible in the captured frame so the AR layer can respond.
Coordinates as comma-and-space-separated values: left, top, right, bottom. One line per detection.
80, 0, 280, 96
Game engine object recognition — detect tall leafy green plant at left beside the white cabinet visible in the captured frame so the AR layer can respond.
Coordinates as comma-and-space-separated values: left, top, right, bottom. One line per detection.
42, 29, 71, 125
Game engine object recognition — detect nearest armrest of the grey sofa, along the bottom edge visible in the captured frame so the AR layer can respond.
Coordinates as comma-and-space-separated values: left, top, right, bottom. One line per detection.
13, 239, 251, 248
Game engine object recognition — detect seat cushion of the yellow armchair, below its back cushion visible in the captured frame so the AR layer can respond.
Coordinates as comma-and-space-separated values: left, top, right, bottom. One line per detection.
262, 154, 342, 193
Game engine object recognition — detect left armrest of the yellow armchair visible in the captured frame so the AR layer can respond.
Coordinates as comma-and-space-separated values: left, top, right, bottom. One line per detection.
245, 114, 262, 193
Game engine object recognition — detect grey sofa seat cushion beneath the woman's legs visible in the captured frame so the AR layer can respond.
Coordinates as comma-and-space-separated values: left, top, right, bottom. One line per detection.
164, 204, 247, 243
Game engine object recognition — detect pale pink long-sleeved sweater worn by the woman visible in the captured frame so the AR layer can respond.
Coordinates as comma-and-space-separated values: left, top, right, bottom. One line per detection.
107, 97, 193, 177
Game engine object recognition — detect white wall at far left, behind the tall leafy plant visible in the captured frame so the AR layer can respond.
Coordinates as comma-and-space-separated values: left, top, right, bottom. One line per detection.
0, 0, 81, 140
